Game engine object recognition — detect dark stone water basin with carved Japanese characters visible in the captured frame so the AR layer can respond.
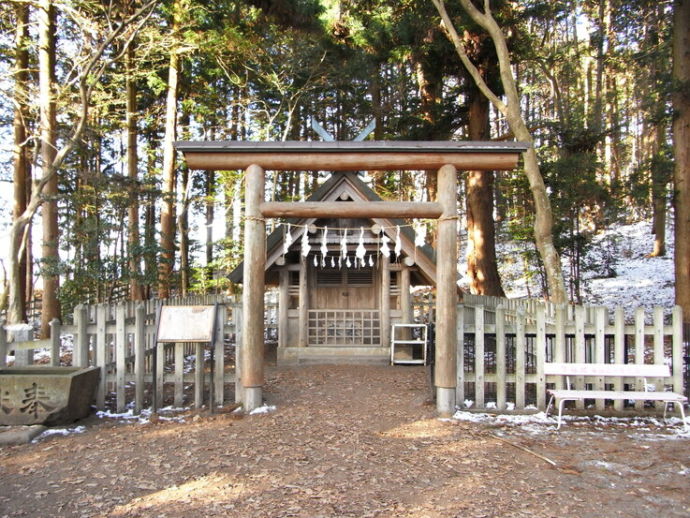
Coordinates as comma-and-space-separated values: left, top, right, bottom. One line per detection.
0, 366, 100, 426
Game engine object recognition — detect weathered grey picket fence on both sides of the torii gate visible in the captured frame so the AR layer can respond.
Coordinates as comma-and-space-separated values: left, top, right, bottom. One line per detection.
0, 293, 687, 412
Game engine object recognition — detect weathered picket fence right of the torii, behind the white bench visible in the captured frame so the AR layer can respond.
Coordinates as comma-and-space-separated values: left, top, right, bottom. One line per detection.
457, 297, 685, 411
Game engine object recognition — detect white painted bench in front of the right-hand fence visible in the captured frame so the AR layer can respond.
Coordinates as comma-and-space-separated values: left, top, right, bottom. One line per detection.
544, 363, 688, 430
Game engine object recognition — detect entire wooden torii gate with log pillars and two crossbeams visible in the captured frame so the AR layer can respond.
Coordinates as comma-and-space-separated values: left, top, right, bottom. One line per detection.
175, 141, 527, 416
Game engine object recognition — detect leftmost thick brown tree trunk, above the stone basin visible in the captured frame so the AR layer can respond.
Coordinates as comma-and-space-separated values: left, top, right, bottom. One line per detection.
7, 3, 31, 323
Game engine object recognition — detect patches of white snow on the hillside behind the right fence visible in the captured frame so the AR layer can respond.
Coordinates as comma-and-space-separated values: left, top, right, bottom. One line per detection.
460, 218, 674, 315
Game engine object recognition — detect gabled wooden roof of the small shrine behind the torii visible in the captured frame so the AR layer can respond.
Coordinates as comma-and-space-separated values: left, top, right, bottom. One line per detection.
229, 172, 436, 284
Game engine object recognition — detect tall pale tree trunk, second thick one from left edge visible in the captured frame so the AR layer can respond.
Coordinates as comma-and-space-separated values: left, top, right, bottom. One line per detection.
38, 0, 60, 338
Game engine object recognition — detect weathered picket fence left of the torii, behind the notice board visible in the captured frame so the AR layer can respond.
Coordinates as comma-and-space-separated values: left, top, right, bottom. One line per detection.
0, 295, 278, 413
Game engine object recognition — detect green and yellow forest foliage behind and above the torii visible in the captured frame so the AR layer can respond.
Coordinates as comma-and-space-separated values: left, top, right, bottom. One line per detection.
0, 0, 673, 308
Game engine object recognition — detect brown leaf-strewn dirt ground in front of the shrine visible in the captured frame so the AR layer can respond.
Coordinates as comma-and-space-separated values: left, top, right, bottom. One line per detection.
0, 366, 690, 518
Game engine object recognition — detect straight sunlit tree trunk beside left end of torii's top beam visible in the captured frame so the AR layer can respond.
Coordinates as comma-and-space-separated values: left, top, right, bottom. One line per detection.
158, 1, 180, 299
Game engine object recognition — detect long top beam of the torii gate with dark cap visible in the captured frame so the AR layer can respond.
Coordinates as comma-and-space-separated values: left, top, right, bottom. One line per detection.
175, 140, 528, 171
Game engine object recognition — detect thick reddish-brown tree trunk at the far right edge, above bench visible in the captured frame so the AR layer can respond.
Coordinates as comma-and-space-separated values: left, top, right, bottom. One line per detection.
673, 0, 690, 322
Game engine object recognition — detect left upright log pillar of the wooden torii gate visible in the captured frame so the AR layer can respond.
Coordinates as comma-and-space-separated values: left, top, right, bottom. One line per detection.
241, 164, 266, 412
